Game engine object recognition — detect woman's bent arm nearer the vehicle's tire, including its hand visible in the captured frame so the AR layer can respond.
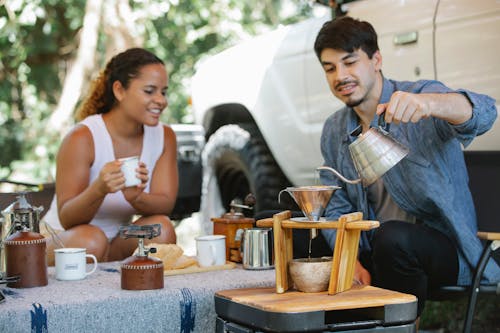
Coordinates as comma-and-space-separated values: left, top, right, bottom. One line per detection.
123, 126, 179, 215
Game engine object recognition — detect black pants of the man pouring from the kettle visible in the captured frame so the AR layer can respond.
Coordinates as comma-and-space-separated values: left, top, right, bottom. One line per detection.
359, 221, 458, 316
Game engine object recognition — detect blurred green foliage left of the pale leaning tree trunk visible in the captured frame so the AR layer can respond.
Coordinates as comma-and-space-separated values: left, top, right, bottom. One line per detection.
0, 0, 85, 181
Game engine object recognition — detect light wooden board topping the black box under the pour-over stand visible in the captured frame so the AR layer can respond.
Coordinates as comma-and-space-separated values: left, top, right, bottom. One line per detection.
216, 286, 417, 313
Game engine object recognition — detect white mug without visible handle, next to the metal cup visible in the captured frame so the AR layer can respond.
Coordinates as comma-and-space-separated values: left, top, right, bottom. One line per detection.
196, 235, 226, 267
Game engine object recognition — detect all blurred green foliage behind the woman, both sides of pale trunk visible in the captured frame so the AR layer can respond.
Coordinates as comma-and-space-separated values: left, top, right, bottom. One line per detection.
0, 0, 311, 181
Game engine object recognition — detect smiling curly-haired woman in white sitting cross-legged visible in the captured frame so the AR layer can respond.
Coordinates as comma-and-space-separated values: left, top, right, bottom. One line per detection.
45, 48, 178, 265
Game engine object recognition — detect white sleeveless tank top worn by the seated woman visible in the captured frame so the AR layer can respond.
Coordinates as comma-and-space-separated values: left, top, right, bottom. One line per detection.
44, 114, 164, 239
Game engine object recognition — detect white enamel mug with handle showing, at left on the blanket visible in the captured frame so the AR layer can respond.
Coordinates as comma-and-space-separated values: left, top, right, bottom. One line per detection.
54, 247, 97, 280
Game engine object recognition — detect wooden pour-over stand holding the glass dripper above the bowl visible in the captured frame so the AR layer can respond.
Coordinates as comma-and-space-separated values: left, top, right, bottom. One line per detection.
257, 211, 379, 295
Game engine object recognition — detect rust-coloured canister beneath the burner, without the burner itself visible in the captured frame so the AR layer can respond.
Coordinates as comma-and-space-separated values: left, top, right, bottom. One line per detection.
121, 256, 163, 290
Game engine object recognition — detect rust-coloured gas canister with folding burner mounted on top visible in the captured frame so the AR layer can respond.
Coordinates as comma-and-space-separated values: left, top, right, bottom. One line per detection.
120, 224, 163, 290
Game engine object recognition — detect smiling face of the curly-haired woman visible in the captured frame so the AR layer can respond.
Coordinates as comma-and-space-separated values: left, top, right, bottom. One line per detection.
114, 64, 168, 126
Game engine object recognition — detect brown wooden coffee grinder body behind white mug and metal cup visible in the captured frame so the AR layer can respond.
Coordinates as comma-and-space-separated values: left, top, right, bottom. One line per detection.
211, 211, 254, 262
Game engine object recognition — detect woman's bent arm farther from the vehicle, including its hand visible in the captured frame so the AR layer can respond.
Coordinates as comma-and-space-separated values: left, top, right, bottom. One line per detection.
56, 125, 124, 229
